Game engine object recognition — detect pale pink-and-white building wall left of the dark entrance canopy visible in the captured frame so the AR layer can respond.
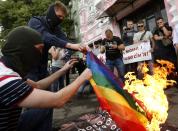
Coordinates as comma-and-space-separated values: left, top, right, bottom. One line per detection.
79, 0, 120, 44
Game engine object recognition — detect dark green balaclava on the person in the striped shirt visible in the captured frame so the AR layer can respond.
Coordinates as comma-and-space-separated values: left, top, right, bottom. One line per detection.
2, 26, 43, 77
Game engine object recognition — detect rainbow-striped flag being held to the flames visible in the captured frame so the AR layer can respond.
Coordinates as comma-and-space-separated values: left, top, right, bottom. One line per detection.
87, 52, 148, 131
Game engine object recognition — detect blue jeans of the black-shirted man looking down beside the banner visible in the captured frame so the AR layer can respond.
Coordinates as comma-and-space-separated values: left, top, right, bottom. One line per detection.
106, 58, 125, 82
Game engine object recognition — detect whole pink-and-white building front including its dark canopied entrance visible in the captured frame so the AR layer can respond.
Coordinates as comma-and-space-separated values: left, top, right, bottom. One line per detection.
71, 0, 178, 44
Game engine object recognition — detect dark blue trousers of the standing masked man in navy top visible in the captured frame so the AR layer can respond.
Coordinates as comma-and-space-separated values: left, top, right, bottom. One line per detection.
17, 70, 53, 131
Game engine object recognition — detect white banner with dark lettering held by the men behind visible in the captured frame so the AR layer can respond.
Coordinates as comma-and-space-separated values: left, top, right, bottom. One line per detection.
123, 42, 152, 64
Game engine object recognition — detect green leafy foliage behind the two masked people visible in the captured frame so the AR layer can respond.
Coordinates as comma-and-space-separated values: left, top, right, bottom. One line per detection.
0, 0, 71, 47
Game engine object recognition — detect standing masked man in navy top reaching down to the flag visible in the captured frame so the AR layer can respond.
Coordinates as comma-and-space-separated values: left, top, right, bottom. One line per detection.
18, 1, 87, 131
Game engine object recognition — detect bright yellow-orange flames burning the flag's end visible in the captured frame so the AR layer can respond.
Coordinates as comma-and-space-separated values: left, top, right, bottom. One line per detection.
124, 60, 176, 131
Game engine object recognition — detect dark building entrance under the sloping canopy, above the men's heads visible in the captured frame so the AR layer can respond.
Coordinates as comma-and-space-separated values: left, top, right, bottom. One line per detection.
96, 0, 168, 34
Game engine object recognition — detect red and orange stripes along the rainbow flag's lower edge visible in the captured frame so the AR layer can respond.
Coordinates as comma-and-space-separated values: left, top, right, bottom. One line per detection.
92, 82, 147, 131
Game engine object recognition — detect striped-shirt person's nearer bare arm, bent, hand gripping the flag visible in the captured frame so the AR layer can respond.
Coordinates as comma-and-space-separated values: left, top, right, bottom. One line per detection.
18, 69, 92, 108
